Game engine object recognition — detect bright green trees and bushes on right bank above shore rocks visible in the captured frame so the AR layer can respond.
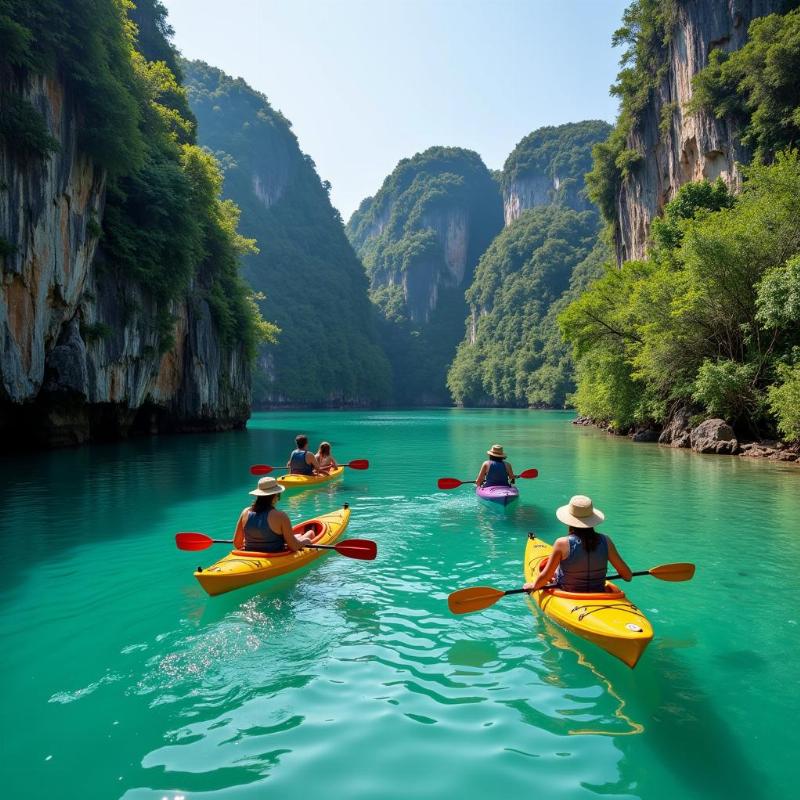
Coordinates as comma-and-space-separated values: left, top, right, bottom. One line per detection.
560, 152, 800, 438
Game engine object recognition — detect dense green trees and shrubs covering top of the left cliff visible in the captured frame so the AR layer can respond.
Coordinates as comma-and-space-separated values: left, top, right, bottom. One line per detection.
0, 0, 274, 354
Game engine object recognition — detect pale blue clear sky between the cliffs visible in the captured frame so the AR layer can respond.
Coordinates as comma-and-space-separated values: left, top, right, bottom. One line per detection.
163, 0, 629, 220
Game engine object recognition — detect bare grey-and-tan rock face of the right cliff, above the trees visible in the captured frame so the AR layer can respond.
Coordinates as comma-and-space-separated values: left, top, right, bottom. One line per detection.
615, 0, 785, 264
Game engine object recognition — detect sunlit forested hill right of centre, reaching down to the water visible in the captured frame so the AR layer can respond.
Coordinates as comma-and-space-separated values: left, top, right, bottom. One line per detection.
447, 205, 608, 407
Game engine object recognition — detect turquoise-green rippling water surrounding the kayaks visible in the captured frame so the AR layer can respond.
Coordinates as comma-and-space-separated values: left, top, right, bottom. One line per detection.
0, 410, 800, 800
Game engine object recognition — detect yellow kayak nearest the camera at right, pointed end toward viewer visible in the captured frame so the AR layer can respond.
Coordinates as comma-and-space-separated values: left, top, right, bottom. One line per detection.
525, 534, 653, 668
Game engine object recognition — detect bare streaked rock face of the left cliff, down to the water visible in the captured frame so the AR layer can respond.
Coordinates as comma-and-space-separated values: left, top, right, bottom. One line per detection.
0, 72, 250, 445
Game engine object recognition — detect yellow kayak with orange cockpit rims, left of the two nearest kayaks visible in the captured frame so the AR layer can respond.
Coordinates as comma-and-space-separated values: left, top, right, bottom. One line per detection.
194, 503, 350, 595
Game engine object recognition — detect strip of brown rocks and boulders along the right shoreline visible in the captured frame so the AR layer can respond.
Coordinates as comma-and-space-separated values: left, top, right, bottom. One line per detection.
572, 408, 800, 465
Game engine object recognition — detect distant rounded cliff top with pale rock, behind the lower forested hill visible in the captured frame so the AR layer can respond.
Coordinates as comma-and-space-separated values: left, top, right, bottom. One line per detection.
502, 120, 611, 225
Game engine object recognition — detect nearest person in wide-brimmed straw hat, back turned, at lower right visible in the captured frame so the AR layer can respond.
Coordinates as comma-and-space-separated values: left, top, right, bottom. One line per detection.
523, 494, 632, 592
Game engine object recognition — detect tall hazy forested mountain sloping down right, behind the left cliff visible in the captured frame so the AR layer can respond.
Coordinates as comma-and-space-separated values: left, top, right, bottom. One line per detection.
182, 61, 389, 405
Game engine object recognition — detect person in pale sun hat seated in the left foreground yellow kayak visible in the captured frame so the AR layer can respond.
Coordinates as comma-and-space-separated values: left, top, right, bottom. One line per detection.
233, 477, 313, 553
